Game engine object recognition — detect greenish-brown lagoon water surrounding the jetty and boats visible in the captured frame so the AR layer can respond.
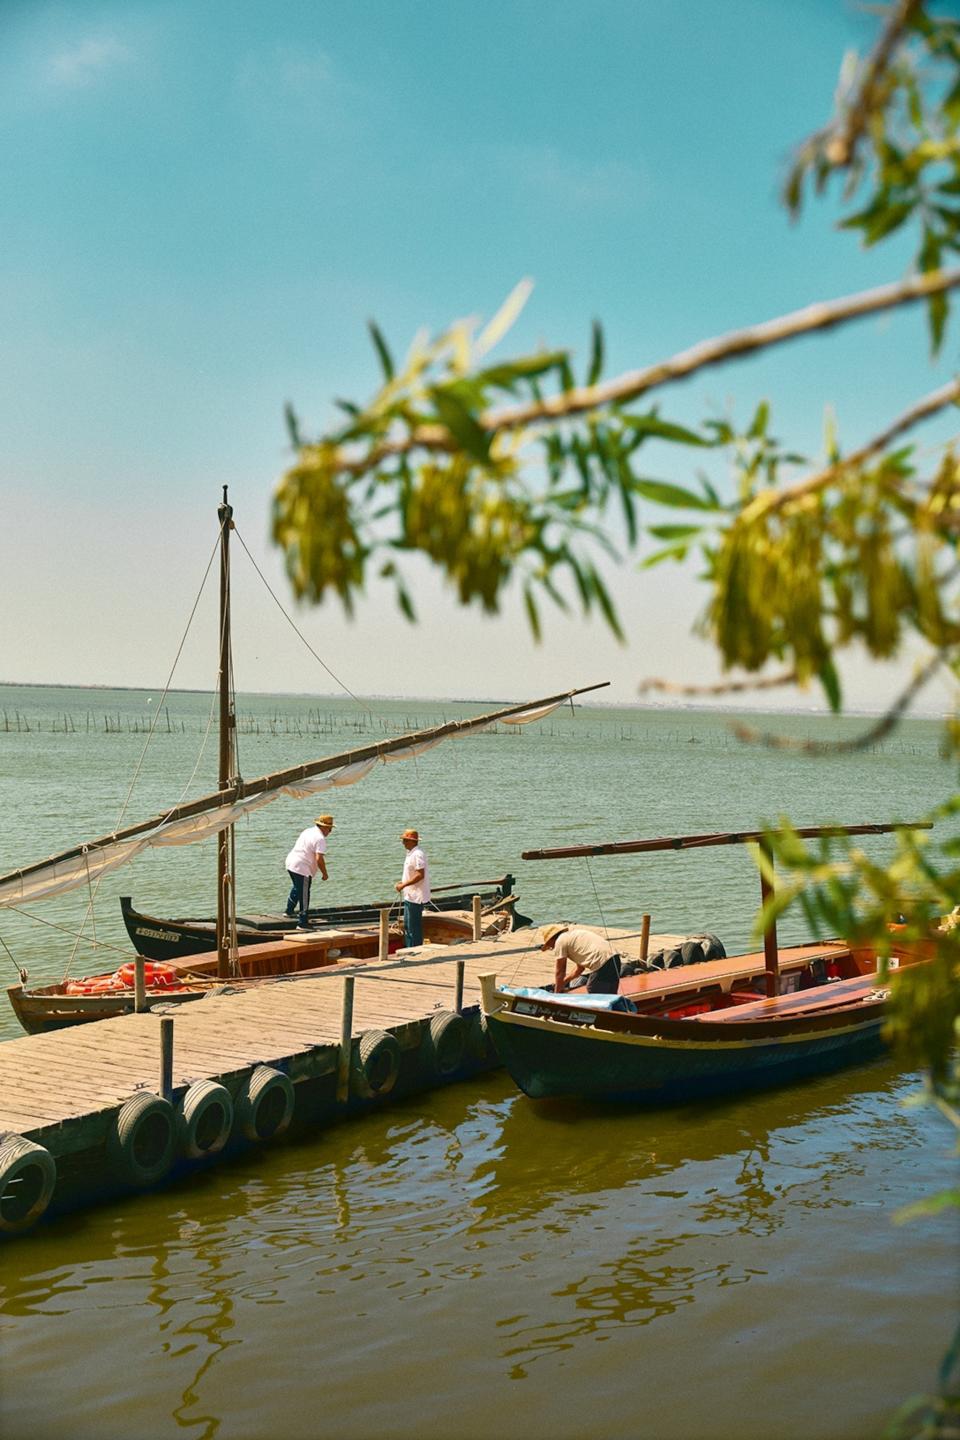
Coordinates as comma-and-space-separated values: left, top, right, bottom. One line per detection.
0, 687, 959, 1440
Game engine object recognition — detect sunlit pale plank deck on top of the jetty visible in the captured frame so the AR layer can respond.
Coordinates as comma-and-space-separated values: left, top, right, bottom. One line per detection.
0, 929, 684, 1156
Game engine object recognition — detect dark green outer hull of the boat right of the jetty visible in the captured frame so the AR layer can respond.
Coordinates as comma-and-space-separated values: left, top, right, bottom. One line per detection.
486, 1007, 885, 1104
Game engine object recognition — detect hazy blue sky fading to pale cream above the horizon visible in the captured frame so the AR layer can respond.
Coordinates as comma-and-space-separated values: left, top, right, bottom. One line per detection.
0, 0, 956, 710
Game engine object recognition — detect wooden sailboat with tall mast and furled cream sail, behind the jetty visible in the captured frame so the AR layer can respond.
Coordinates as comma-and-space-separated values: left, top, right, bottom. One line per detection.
0, 487, 602, 1031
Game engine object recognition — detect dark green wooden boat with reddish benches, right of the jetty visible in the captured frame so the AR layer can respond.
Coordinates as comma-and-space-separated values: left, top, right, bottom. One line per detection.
481, 825, 931, 1104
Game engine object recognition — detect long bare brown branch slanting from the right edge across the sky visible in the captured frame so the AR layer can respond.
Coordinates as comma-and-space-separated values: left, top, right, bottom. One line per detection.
326, 269, 960, 475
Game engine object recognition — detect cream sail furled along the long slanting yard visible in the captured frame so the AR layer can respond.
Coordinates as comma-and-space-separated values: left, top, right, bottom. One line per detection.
0, 681, 609, 909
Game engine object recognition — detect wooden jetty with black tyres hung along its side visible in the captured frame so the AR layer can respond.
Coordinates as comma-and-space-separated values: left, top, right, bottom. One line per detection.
0, 929, 682, 1234
